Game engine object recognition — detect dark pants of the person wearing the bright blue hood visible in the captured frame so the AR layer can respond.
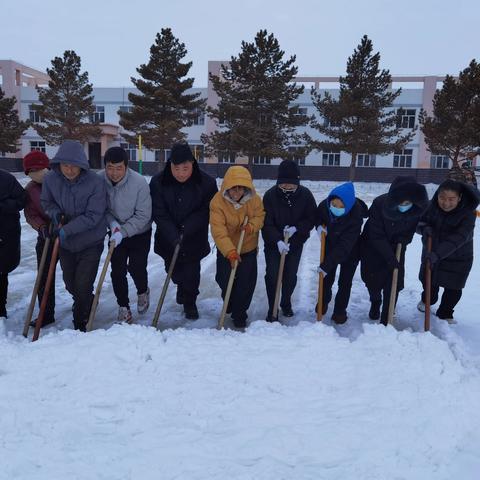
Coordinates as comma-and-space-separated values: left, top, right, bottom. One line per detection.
323, 258, 359, 314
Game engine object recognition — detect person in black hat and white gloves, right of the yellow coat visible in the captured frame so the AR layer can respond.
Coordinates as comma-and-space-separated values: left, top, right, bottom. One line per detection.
262, 160, 316, 322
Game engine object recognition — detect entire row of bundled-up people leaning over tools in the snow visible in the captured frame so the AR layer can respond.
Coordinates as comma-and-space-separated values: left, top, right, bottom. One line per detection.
0, 140, 479, 330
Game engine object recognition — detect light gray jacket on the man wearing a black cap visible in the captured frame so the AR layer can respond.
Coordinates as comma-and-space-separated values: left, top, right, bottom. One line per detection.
100, 168, 152, 237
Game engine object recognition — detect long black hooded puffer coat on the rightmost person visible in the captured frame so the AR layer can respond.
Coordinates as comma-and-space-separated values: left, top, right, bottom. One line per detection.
419, 180, 480, 290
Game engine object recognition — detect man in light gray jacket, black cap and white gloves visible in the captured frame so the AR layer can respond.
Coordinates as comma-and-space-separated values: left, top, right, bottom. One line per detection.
101, 147, 152, 323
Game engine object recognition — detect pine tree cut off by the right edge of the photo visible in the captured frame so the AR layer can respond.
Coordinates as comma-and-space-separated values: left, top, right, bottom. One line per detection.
420, 60, 480, 167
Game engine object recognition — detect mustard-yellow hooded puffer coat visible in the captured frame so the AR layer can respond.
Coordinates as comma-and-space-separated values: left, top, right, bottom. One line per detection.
210, 165, 265, 257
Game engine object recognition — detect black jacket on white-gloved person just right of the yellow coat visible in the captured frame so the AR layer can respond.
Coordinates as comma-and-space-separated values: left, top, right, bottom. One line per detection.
262, 185, 317, 250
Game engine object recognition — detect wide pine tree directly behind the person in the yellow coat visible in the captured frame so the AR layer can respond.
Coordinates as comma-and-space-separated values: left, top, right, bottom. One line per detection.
202, 30, 309, 166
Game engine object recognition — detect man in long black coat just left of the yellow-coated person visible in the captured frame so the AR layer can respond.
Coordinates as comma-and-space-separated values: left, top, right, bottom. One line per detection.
150, 143, 217, 320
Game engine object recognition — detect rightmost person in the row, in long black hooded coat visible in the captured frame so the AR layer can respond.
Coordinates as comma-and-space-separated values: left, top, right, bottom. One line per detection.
417, 180, 480, 323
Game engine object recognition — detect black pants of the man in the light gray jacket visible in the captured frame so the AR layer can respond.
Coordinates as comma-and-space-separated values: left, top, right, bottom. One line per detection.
111, 230, 152, 307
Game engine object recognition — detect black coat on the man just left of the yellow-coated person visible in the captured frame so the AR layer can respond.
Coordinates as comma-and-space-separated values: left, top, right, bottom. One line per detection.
150, 161, 218, 262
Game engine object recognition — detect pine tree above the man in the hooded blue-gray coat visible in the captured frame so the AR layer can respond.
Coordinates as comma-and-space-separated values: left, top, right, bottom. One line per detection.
33, 50, 101, 145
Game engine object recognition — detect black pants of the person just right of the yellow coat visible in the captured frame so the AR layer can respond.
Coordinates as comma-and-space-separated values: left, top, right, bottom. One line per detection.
265, 247, 303, 315
